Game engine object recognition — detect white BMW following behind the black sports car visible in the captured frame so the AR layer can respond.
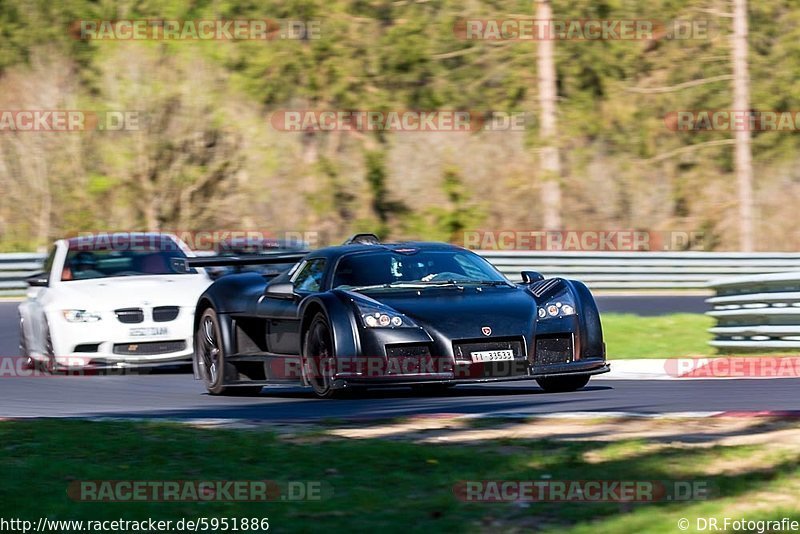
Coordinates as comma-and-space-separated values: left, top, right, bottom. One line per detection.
19, 233, 211, 371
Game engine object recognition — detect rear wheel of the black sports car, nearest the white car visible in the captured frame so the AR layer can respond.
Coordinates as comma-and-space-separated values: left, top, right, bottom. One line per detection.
194, 308, 262, 395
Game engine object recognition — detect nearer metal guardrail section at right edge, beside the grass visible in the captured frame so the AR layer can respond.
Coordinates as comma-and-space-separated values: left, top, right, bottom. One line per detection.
706, 271, 800, 351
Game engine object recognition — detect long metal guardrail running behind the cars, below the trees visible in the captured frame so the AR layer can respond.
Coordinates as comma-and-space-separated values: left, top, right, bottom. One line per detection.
0, 250, 800, 298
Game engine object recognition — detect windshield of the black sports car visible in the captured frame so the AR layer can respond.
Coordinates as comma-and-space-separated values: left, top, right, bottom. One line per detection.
333, 249, 507, 288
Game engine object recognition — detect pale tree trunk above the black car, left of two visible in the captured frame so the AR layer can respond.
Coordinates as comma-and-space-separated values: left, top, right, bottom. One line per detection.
536, 0, 561, 230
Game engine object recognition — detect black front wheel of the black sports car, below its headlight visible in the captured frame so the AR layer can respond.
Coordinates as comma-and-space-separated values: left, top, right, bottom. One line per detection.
303, 313, 340, 399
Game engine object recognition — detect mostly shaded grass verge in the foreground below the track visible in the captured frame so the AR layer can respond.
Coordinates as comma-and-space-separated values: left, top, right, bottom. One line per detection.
0, 420, 800, 532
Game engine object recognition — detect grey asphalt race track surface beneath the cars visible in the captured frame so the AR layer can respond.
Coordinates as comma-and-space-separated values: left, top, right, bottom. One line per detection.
0, 297, 800, 421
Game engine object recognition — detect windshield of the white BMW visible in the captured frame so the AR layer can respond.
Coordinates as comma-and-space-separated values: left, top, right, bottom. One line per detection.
61, 239, 197, 281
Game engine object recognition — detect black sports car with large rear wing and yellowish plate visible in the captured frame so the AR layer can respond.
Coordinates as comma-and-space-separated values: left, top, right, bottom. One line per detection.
187, 234, 609, 398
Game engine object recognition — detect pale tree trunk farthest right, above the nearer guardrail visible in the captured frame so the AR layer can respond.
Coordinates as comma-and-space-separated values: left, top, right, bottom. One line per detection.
732, 0, 754, 252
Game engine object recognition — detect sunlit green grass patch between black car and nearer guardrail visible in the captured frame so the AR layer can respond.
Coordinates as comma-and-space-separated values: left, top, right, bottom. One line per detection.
601, 313, 718, 360
